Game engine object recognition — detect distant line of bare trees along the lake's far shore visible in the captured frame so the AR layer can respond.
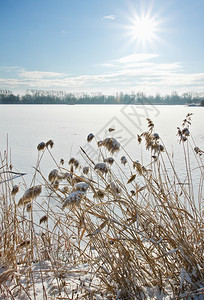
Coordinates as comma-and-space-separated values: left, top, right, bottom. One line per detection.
0, 89, 204, 105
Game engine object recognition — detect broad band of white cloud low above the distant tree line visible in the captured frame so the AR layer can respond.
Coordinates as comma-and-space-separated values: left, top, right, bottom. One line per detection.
0, 53, 204, 93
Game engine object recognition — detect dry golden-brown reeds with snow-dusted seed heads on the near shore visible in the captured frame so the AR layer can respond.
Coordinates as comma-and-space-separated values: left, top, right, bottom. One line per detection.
0, 114, 204, 300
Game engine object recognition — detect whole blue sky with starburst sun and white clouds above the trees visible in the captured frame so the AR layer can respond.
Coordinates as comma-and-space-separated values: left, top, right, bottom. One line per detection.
0, 0, 204, 94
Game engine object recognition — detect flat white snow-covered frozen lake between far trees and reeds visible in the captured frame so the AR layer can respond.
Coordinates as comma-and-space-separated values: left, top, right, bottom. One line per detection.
0, 105, 204, 185
